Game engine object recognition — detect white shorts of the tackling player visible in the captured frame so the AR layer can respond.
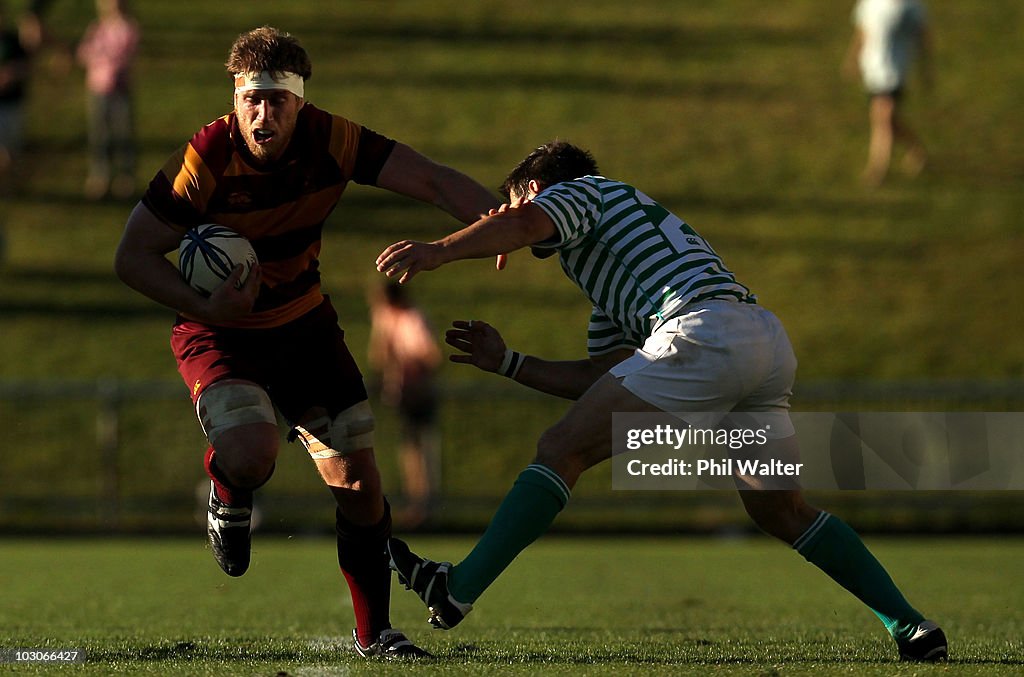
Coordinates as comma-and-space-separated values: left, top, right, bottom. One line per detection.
610, 299, 797, 438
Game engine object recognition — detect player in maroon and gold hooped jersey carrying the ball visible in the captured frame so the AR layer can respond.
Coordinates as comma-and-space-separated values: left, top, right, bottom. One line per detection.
115, 27, 498, 659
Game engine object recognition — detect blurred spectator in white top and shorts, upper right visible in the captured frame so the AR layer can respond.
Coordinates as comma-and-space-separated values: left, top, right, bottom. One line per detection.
845, 0, 931, 185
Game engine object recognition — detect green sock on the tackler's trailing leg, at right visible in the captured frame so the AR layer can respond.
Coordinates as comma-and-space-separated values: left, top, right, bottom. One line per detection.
793, 512, 925, 639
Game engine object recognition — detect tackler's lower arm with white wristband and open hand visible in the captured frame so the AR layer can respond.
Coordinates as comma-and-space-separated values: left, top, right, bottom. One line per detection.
444, 320, 633, 399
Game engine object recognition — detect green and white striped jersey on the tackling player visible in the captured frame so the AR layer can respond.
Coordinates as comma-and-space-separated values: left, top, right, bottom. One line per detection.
532, 176, 756, 355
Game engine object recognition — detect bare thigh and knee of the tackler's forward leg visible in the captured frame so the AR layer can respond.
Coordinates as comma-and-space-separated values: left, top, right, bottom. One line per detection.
536, 374, 660, 489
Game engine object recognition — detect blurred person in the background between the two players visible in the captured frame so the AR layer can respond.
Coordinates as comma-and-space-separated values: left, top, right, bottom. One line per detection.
370, 283, 441, 528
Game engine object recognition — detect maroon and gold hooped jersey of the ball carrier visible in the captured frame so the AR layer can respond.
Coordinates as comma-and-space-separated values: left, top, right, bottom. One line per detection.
142, 103, 394, 328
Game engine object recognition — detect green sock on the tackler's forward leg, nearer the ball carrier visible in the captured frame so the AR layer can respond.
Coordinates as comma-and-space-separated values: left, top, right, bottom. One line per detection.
449, 463, 569, 604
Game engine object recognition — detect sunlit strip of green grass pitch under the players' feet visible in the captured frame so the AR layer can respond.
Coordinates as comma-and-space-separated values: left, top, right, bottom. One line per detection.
0, 534, 1024, 677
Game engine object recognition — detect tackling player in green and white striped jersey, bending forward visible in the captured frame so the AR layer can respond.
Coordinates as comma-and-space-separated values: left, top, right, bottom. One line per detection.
377, 141, 946, 661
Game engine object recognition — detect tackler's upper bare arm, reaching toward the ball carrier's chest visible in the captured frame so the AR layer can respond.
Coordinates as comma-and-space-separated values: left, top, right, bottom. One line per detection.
377, 203, 555, 284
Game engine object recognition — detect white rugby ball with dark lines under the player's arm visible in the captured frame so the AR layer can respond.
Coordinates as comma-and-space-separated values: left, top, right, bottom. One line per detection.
178, 223, 257, 296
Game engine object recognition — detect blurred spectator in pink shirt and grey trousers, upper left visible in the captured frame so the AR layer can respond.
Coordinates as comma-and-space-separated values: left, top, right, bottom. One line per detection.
77, 0, 139, 200
